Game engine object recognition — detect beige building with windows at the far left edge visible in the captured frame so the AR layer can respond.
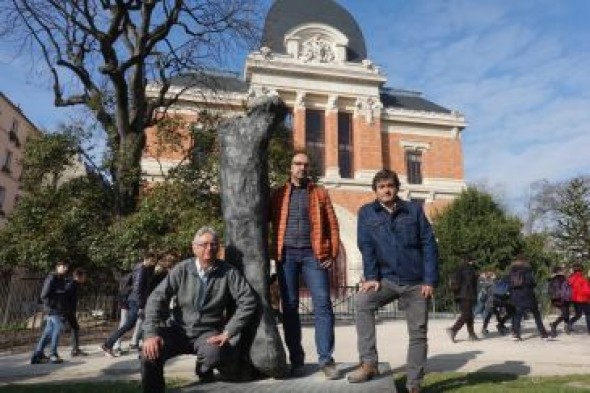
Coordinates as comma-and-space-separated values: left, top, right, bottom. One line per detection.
0, 92, 40, 228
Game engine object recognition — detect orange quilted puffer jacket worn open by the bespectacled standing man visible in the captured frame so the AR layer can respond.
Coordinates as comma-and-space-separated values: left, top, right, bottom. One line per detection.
271, 182, 340, 261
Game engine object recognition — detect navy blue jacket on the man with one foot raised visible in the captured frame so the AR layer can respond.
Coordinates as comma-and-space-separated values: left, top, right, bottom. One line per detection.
357, 199, 439, 286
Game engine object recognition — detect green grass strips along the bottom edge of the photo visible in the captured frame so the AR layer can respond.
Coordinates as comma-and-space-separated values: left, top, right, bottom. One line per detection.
0, 373, 590, 393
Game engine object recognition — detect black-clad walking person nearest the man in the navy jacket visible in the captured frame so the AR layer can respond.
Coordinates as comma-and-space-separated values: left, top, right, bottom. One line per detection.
447, 258, 478, 342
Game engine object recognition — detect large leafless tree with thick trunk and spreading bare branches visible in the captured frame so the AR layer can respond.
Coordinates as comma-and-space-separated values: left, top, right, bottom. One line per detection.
0, 0, 259, 214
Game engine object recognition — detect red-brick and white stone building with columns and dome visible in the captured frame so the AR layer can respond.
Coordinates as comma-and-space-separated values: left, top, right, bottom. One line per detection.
142, 0, 466, 285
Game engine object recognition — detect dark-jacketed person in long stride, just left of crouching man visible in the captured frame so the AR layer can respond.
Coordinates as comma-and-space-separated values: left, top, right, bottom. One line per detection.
100, 251, 157, 357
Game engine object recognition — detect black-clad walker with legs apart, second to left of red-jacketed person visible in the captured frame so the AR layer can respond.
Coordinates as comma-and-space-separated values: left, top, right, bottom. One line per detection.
510, 255, 549, 341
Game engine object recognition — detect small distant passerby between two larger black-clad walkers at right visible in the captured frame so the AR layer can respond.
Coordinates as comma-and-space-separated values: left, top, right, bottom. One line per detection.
481, 276, 514, 335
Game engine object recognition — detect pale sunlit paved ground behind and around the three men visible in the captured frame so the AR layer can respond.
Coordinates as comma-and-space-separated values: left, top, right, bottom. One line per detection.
0, 320, 590, 393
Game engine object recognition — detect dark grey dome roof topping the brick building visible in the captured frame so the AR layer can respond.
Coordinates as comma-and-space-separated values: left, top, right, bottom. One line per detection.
262, 0, 367, 62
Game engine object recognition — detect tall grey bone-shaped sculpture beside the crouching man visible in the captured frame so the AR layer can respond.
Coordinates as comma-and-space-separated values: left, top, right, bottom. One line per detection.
219, 97, 287, 377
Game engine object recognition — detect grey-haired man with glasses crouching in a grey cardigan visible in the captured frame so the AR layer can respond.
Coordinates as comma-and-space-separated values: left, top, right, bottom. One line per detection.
141, 227, 257, 393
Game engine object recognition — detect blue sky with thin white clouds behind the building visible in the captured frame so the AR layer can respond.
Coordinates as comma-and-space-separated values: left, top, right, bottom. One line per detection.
0, 0, 590, 210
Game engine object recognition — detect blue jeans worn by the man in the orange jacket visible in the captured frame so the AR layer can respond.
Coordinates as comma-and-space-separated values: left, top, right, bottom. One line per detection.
278, 248, 334, 367
